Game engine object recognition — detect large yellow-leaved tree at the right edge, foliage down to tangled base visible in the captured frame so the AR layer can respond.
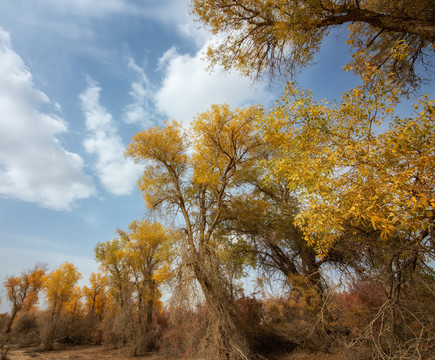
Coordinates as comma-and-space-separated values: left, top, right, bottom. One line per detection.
259, 68, 435, 358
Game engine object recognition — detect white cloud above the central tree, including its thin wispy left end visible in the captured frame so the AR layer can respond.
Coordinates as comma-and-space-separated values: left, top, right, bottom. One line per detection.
119, 41, 275, 127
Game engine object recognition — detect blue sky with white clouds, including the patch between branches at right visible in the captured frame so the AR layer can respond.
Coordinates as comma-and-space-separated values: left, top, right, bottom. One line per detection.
0, 0, 434, 311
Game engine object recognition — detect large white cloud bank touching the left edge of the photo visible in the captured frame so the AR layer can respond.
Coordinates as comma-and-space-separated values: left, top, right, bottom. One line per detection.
0, 28, 95, 210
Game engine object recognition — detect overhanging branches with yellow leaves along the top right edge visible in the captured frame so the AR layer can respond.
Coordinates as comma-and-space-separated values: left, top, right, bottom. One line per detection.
192, 0, 435, 88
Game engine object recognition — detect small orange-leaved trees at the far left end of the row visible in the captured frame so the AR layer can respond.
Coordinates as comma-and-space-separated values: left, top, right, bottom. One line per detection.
1, 262, 86, 357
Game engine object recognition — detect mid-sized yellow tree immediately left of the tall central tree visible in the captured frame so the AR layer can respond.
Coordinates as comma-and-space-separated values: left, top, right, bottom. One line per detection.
95, 220, 174, 355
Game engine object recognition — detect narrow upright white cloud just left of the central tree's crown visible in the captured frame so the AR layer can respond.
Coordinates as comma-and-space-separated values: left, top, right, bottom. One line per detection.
80, 78, 143, 195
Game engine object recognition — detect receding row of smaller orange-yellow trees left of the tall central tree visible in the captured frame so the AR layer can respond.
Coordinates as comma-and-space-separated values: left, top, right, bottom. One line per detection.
1, 220, 173, 355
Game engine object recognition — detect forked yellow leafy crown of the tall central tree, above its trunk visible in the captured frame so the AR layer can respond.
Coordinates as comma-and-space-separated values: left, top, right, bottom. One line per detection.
128, 105, 262, 246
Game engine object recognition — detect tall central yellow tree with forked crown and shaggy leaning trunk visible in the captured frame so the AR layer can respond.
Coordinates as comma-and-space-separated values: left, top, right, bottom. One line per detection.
128, 105, 262, 359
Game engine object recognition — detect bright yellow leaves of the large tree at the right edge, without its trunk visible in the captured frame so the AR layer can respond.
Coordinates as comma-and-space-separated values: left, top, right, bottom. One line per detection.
262, 82, 435, 255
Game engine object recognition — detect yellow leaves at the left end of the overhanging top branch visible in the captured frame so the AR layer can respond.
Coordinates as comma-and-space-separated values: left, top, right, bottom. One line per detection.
192, 0, 327, 76
